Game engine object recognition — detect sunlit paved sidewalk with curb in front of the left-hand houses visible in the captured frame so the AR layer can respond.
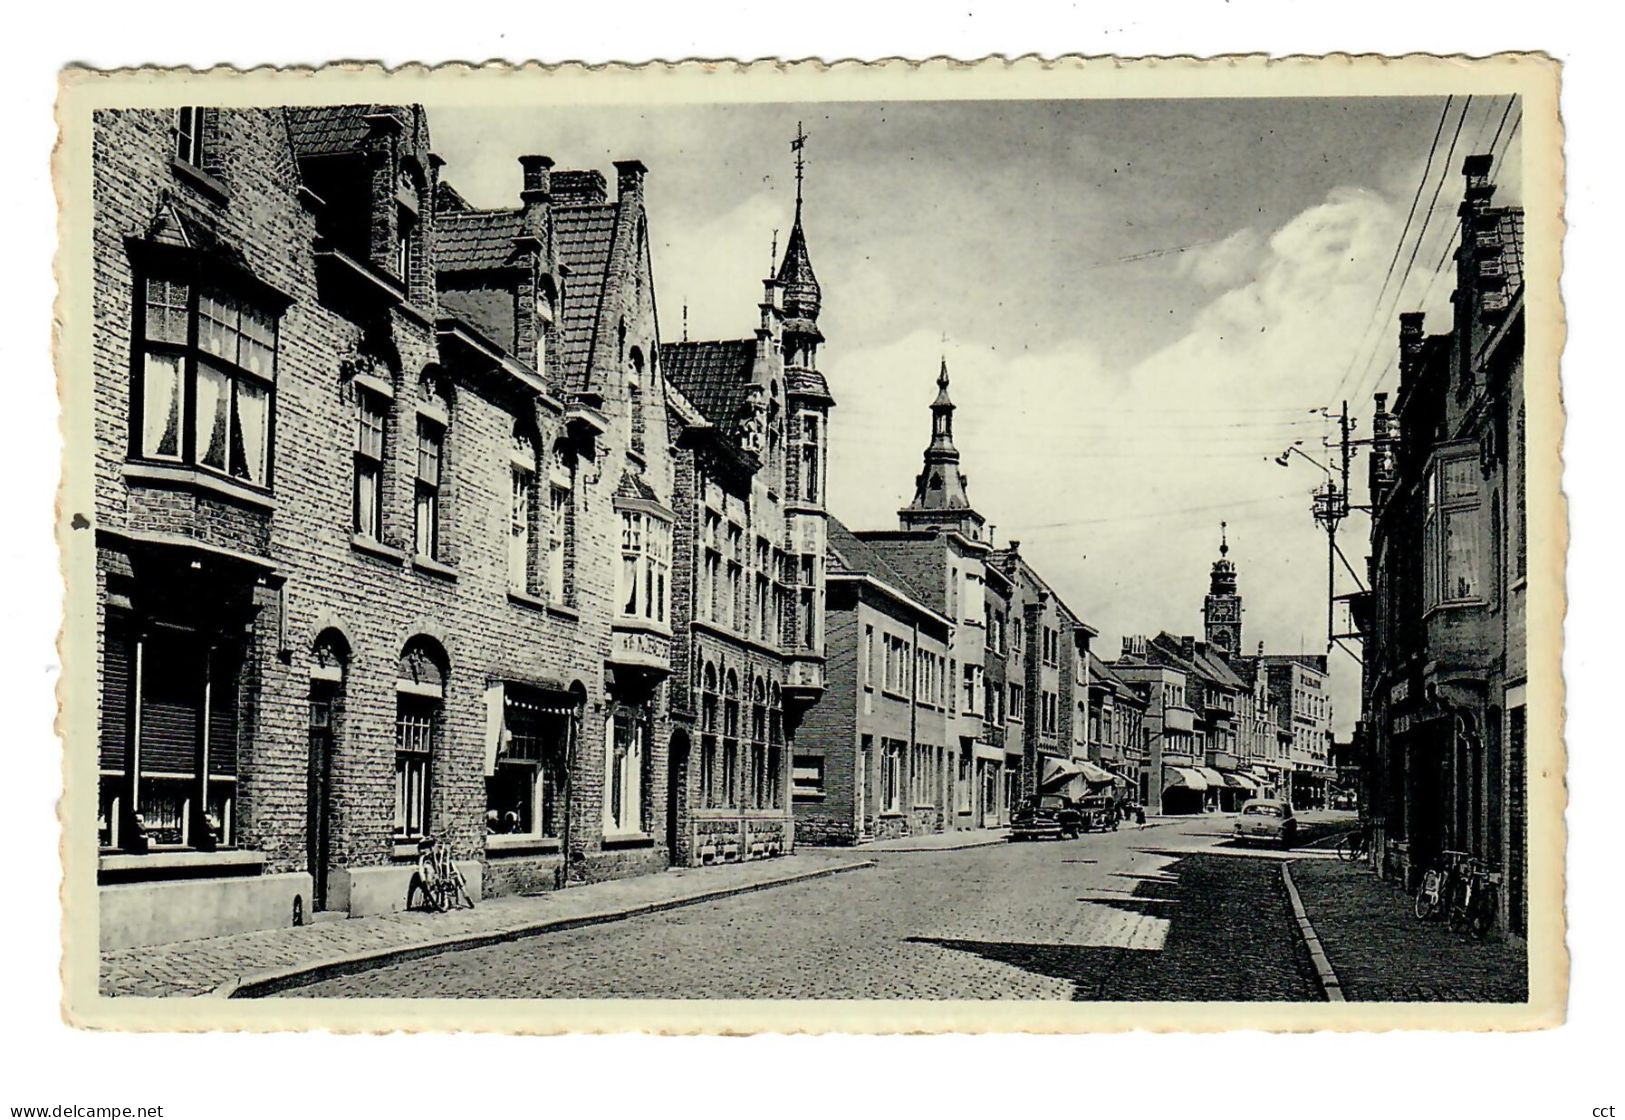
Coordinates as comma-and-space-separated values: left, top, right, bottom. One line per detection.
101, 850, 873, 996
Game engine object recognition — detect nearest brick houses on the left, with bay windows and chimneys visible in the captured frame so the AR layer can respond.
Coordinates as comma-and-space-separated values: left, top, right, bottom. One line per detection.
93, 106, 692, 946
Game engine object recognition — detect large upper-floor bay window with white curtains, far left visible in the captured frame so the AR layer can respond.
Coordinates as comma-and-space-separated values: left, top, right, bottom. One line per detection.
130, 275, 276, 488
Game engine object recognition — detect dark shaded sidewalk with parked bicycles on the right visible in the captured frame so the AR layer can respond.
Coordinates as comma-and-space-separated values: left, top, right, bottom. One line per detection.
1292, 860, 1529, 1003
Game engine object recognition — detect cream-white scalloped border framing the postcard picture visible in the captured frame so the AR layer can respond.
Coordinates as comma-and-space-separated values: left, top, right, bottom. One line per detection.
54, 54, 1568, 1034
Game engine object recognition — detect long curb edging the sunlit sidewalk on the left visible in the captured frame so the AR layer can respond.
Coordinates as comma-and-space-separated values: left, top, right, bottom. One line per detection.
216, 860, 874, 1000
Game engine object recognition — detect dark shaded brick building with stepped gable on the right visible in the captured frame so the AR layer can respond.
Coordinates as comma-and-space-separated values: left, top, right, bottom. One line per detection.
1360, 154, 1529, 936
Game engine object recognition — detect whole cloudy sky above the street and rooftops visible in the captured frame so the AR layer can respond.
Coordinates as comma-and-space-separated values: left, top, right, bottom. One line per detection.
431, 96, 1521, 733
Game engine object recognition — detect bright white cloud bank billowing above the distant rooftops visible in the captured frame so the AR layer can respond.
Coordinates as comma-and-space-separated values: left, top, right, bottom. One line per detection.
827, 183, 1448, 728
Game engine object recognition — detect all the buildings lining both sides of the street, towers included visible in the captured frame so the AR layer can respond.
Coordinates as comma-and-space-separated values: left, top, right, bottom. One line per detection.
82, 106, 1524, 968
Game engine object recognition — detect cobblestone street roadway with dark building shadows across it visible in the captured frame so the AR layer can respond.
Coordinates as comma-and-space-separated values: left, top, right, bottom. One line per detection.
286, 818, 1320, 1000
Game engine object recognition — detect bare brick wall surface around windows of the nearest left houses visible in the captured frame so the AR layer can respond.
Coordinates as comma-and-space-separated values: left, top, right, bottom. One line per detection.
94, 111, 685, 910
